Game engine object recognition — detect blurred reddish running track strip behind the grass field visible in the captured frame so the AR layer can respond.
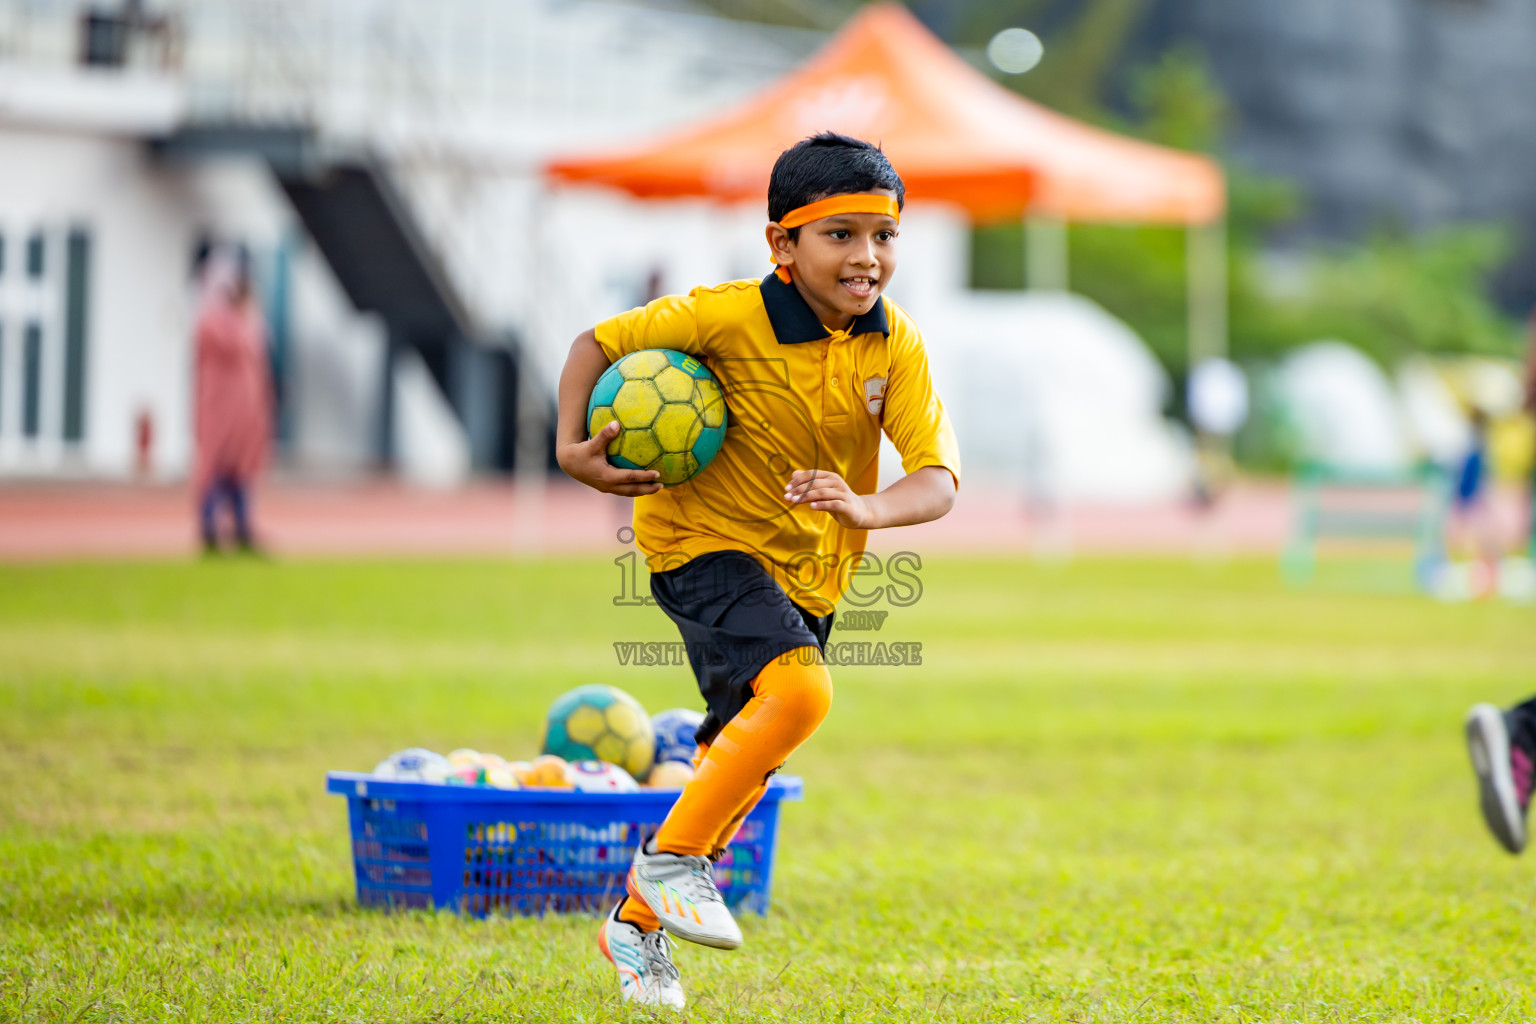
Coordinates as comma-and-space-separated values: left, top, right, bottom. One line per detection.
0, 479, 1290, 562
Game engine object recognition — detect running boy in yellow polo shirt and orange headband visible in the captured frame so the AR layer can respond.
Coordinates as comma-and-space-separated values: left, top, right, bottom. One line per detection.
556, 132, 960, 1007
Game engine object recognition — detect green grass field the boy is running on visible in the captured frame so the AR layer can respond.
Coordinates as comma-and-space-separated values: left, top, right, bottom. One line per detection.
0, 557, 1536, 1021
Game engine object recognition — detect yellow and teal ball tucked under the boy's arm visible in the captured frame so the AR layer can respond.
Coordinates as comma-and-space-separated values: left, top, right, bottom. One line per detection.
587, 348, 725, 487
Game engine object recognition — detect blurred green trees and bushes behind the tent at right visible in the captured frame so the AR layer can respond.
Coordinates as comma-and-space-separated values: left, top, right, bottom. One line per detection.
971, 40, 1519, 379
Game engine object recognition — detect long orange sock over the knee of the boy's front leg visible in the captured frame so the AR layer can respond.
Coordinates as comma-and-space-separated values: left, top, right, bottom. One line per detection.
654, 646, 833, 859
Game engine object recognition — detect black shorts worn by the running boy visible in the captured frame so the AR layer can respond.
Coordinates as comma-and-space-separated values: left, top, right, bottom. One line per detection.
651, 551, 833, 743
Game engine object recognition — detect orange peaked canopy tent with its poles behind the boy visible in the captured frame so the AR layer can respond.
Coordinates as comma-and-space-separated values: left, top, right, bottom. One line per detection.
547, 3, 1226, 355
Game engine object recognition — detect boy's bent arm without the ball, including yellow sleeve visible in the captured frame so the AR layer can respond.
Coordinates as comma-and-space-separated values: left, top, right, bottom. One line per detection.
783, 319, 960, 530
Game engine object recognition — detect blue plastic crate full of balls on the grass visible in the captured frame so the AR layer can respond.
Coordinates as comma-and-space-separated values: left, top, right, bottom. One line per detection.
326, 772, 803, 917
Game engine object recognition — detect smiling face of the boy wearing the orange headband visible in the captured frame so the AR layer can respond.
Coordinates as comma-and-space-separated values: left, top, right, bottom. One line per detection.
768, 189, 897, 330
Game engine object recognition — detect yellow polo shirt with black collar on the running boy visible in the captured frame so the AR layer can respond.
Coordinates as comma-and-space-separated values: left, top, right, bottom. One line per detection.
596, 268, 960, 616
